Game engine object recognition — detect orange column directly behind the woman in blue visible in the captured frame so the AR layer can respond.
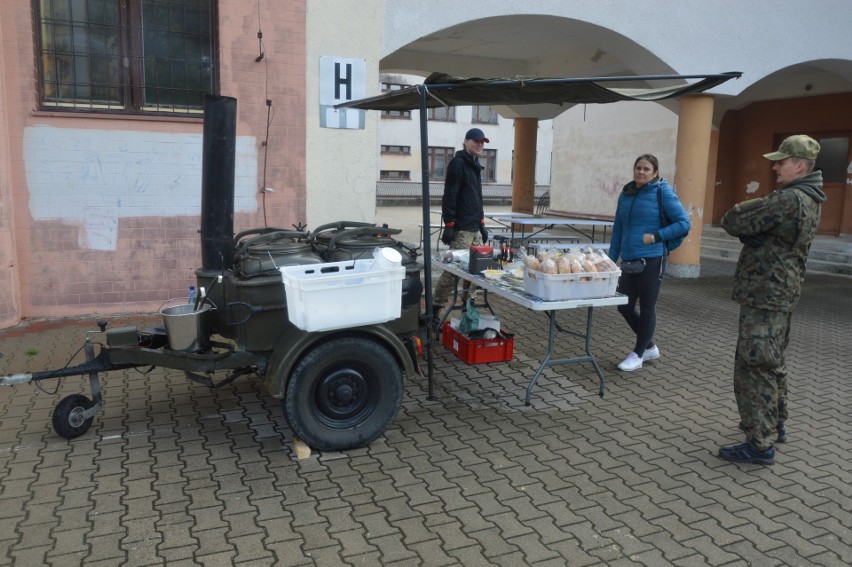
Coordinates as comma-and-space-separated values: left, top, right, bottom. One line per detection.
668, 95, 713, 278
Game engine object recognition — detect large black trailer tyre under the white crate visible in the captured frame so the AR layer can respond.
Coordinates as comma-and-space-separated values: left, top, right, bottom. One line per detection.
281, 337, 403, 451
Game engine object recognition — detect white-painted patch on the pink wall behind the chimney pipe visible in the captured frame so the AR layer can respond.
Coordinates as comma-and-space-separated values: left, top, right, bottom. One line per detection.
24, 126, 258, 250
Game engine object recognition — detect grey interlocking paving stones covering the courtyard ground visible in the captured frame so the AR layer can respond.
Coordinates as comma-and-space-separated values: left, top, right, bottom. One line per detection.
0, 211, 852, 567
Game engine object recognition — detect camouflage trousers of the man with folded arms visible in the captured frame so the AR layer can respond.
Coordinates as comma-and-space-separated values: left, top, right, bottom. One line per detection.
734, 305, 792, 451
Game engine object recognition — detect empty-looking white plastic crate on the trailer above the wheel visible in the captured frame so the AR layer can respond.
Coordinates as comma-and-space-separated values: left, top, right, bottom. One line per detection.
279, 259, 405, 331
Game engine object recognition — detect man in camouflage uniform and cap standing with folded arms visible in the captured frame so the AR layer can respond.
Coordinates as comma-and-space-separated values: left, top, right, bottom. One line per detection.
719, 135, 825, 464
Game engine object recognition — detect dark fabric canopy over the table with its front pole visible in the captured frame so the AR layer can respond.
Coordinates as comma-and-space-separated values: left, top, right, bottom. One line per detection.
335, 72, 742, 399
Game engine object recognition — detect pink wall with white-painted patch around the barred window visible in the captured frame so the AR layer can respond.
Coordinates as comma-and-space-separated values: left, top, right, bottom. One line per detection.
0, 0, 306, 327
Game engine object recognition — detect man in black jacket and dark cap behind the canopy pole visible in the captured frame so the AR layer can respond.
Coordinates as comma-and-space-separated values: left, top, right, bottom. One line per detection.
432, 128, 489, 319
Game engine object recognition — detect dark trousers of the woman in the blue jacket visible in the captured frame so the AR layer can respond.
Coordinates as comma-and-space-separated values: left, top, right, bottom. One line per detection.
618, 256, 666, 358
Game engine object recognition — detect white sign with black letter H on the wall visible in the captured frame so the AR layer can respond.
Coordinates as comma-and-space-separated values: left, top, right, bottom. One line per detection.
320, 56, 367, 130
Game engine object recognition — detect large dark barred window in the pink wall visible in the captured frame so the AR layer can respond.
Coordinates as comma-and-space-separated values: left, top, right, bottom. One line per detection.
34, 0, 217, 114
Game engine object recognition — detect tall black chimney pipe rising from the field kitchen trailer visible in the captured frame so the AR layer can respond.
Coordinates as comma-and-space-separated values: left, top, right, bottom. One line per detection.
201, 95, 237, 272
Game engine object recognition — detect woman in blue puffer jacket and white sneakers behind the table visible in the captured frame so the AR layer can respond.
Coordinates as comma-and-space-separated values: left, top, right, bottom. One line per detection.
609, 154, 689, 372
